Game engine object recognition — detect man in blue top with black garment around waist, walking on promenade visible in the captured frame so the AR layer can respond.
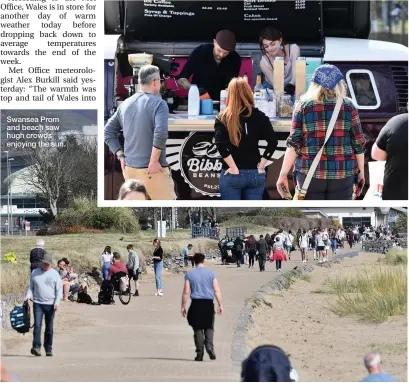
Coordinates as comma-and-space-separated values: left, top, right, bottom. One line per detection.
181, 253, 223, 362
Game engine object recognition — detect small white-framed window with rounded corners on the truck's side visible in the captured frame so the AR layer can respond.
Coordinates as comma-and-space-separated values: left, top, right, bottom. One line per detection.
346, 69, 381, 109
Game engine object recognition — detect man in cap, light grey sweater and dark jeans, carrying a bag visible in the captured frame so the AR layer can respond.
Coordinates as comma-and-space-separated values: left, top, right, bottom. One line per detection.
26, 253, 62, 356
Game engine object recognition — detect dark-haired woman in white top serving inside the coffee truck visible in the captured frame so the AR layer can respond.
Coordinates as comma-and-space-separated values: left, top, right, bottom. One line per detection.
259, 27, 300, 95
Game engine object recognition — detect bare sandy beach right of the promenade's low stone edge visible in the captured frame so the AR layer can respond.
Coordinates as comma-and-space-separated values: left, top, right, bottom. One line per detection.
247, 253, 407, 382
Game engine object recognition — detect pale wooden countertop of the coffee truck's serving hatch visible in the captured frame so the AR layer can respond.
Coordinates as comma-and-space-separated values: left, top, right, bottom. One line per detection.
168, 112, 291, 132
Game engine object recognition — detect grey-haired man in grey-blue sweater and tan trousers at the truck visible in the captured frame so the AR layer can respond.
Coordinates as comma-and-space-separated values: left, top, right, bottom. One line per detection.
104, 65, 176, 200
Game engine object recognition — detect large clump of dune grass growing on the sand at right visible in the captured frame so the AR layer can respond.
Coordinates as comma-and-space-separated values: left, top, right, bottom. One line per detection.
325, 265, 407, 323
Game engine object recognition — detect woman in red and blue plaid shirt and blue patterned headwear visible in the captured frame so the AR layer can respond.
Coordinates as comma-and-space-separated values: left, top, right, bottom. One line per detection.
277, 64, 365, 200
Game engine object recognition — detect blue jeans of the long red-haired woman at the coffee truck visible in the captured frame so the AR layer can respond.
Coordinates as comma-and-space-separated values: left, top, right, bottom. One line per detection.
220, 169, 266, 201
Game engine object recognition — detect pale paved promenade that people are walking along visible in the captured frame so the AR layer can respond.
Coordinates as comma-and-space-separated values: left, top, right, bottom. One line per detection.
2, 252, 354, 382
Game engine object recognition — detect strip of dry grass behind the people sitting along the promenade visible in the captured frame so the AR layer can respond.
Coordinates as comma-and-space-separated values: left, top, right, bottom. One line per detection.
1, 230, 217, 295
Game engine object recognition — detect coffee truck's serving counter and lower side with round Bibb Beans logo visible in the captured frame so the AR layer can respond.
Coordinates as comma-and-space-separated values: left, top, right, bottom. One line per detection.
105, 112, 291, 200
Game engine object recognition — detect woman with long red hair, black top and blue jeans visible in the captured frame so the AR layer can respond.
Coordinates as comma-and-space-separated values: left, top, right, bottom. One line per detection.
214, 78, 277, 200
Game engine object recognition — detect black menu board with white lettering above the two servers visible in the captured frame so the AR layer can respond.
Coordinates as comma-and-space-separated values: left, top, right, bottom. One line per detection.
125, 0, 322, 43
